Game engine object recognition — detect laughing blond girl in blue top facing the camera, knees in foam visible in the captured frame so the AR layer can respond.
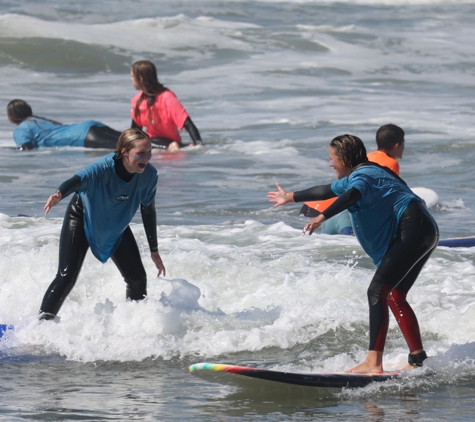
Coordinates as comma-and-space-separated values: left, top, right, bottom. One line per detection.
40, 129, 165, 319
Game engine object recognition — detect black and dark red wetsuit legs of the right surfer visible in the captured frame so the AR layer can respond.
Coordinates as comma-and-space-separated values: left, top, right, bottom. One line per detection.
368, 201, 439, 351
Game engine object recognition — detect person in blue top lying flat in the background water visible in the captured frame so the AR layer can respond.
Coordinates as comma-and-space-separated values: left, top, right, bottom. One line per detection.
7, 99, 120, 150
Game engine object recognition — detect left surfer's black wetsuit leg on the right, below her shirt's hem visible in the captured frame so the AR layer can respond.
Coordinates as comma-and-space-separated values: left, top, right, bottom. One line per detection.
111, 227, 147, 300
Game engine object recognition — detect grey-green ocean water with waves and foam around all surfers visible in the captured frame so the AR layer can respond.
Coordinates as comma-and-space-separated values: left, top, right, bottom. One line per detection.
0, 0, 475, 421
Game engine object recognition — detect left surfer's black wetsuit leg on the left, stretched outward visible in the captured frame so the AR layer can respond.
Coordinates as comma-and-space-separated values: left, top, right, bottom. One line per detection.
40, 195, 89, 319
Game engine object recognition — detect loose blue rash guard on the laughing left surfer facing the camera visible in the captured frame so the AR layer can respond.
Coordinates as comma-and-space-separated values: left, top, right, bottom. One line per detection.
76, 153, 158, 262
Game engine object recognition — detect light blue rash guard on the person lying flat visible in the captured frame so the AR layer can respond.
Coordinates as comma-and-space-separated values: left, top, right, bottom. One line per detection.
13, 117, 104, 148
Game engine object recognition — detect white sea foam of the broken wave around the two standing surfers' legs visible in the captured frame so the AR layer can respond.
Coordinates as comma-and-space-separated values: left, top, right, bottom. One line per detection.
0, 218, 475, 370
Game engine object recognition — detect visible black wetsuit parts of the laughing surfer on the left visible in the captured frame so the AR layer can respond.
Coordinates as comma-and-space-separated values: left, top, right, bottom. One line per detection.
40, 159, 158, 319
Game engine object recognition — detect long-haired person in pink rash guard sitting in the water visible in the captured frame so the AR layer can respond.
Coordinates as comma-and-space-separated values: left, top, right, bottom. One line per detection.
130, 60, 203, 151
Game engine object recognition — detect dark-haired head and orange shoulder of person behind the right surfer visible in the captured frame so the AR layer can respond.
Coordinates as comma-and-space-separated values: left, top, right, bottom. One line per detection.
368, 123, 405, 175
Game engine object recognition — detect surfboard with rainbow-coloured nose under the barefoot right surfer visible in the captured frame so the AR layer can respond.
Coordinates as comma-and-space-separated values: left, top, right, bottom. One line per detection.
188, 362, 400, 388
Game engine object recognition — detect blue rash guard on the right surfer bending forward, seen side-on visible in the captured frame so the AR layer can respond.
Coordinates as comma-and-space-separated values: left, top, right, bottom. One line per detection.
331, 166, 421, 266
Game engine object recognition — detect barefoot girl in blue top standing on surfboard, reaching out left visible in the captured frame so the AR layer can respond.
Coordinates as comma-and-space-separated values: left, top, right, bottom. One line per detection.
267, 135, 439, 374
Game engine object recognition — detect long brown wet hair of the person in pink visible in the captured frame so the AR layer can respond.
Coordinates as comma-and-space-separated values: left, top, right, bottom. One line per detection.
132, 60, 167, 123
